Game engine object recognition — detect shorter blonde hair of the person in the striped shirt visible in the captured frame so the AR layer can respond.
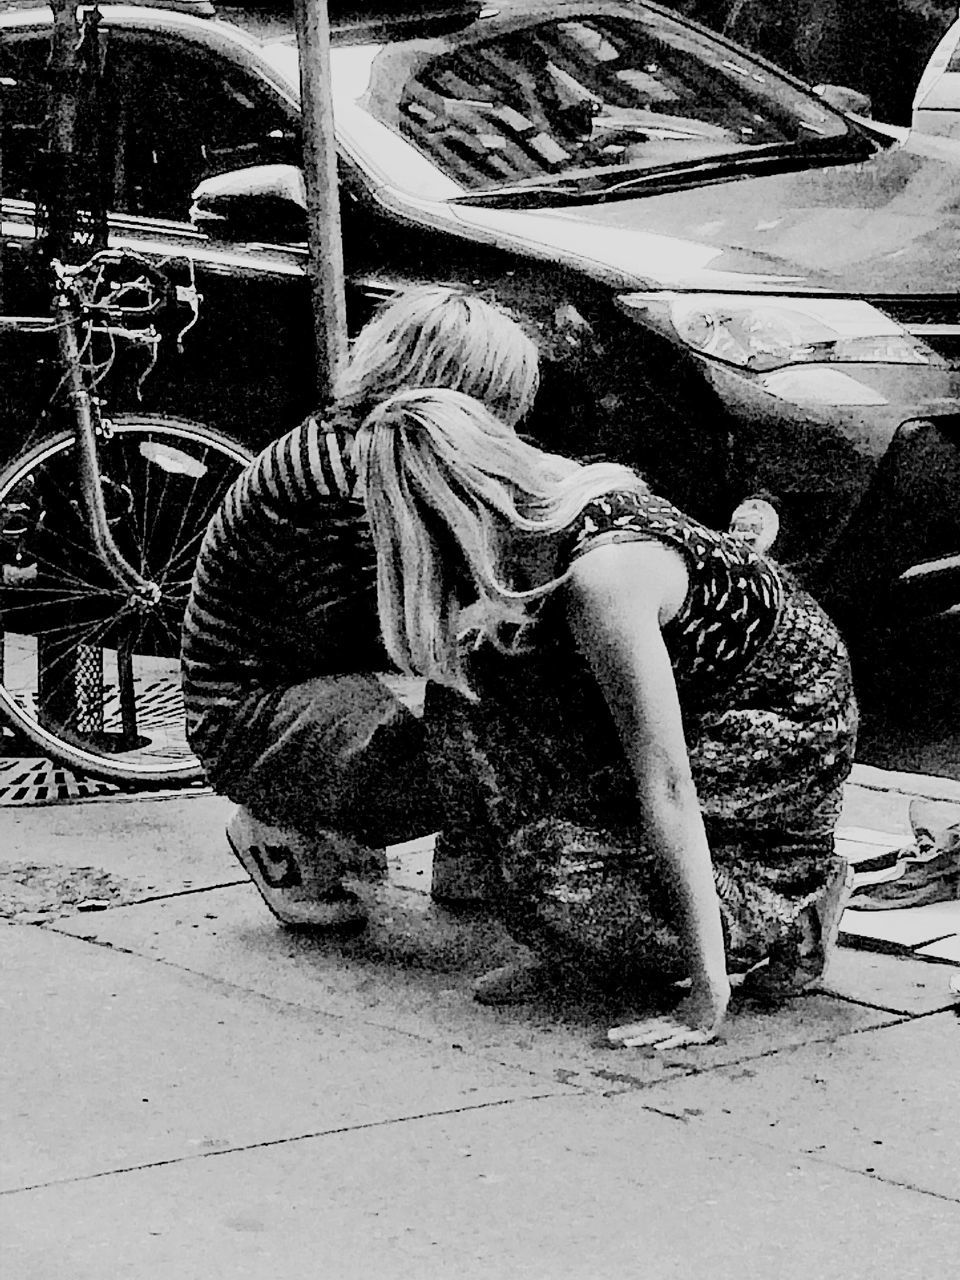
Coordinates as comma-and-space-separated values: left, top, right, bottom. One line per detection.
337, 284, 539, 426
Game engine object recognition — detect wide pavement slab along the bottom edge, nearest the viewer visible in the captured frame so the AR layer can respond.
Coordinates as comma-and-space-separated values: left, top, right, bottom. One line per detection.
0, 1094, 960, 1280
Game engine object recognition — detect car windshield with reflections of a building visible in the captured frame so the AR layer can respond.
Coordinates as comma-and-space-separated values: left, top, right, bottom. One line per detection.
333, 3, 851, 195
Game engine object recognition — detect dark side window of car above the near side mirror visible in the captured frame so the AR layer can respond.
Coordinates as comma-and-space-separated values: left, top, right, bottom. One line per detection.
105, 35, 300, 221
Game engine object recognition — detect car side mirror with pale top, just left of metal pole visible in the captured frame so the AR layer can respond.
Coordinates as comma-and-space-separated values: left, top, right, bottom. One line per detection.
189, 164, 307, 244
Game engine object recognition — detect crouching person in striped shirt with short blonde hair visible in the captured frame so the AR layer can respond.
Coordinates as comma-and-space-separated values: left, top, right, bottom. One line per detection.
182, 285, 539, 928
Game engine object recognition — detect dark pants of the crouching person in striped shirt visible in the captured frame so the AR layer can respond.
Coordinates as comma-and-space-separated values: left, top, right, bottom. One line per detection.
207, 675, 500, 901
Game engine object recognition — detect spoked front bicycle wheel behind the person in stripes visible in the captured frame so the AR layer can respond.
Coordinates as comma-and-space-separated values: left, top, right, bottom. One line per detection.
0, 415, 251, 786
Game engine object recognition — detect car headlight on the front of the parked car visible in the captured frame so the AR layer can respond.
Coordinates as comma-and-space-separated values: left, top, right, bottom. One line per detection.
618, 292, 943, 374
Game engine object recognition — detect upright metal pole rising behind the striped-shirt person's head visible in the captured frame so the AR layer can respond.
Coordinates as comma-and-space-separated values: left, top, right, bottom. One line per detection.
293, 0, 347, 404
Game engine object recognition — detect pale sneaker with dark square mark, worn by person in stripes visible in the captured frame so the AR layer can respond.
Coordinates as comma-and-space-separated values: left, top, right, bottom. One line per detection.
227, 808, 366, 932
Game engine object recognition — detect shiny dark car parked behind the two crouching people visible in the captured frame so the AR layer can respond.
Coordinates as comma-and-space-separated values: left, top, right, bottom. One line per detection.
0, 0, 960, 655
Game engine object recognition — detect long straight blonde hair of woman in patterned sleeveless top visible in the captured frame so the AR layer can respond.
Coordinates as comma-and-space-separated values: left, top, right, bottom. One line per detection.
356, 388, 646, 696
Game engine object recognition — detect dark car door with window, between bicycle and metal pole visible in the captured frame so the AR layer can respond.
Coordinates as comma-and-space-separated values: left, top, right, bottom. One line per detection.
102, 29, 314, 445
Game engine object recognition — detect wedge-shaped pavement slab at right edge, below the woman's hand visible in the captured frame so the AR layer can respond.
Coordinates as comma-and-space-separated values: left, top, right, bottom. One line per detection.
632, 1011, 960, 1198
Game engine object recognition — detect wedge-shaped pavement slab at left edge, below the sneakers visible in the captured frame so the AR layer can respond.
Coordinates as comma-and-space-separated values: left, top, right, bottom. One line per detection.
0, 924, 566, 1192
